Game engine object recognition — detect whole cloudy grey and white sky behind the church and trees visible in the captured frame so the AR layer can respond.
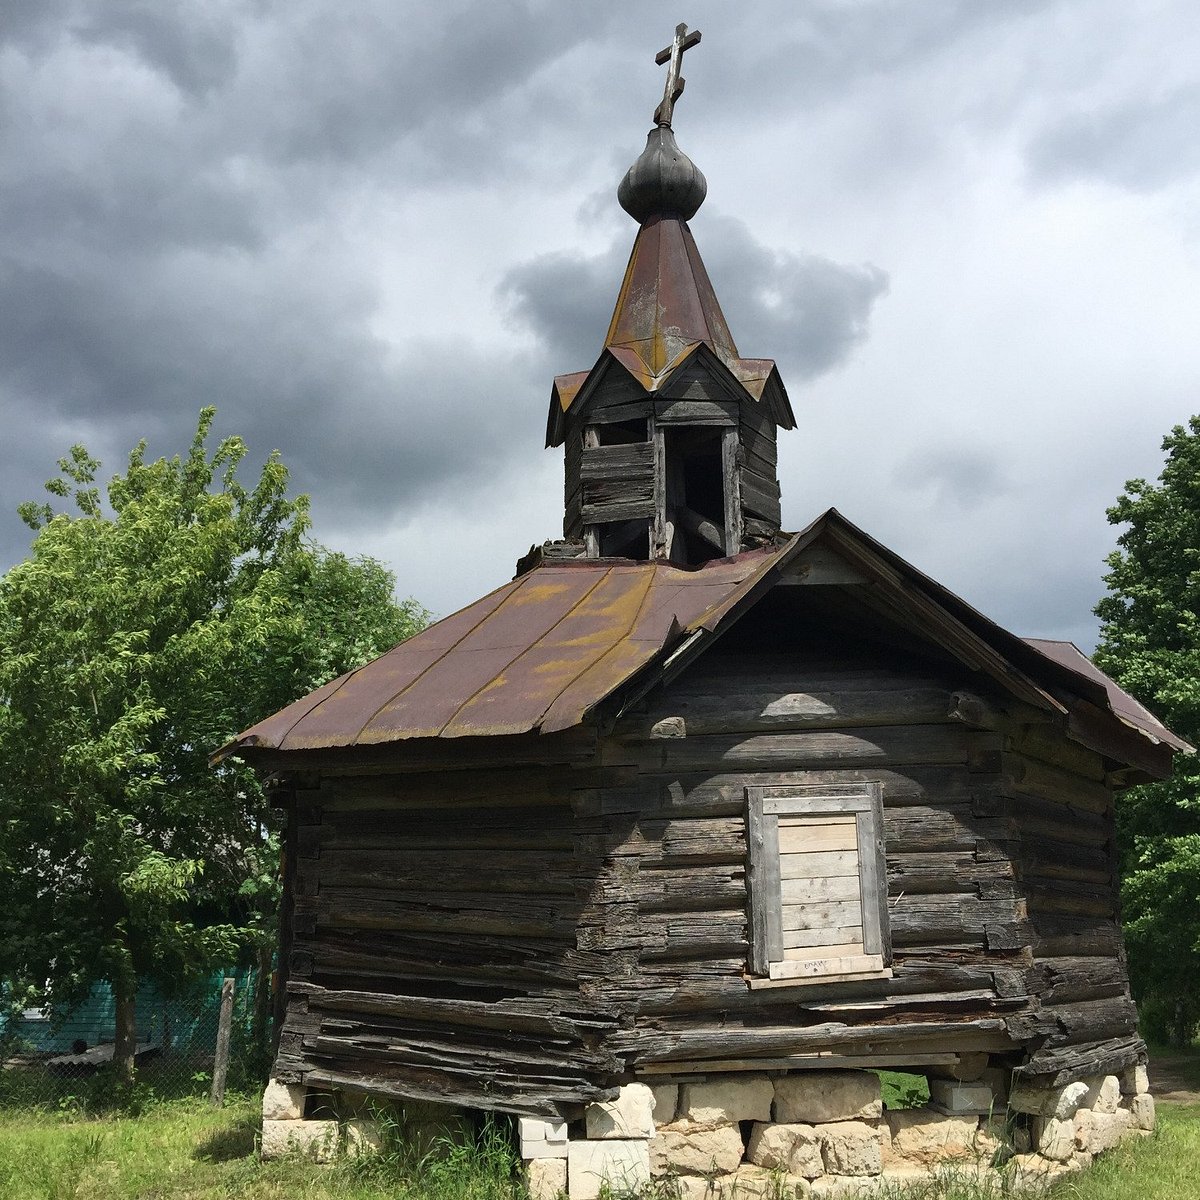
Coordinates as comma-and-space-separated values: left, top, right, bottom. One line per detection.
0, 0, 1200, 649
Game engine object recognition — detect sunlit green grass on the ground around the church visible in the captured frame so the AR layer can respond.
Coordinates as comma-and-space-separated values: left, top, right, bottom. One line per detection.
0, 1094, 1200, 1200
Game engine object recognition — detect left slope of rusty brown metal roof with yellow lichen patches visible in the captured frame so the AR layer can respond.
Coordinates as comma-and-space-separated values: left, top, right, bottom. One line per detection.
225, 550, 775, 750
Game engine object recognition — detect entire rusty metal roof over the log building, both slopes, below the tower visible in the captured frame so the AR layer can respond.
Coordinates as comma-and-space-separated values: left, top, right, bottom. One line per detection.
218, 509, 1190, 755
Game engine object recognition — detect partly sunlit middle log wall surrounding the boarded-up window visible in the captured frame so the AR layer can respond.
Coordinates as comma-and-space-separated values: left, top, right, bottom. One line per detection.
577, 652, 1030, 1064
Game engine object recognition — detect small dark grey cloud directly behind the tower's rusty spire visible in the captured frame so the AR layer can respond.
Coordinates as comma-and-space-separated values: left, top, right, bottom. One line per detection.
500, 217, 888, 380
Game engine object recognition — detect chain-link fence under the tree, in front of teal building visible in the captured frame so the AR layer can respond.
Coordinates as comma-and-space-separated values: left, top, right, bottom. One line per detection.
0, 970, 270, 1109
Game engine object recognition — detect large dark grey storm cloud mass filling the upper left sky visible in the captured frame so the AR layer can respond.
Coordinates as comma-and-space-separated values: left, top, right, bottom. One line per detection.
0, 0, 608, 571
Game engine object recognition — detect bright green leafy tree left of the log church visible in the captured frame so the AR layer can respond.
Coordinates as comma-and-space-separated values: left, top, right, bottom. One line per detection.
0, 409, 428, 1074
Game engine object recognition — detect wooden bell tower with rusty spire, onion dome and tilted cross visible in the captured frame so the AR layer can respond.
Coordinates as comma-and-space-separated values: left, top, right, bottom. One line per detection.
546, 25, 796, 565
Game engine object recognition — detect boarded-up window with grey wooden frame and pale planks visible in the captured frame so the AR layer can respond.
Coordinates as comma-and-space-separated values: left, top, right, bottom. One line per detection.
746, 784, 890, 982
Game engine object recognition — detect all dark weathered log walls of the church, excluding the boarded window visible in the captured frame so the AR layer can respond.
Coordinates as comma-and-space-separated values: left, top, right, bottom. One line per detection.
276, 643, 1144, 1115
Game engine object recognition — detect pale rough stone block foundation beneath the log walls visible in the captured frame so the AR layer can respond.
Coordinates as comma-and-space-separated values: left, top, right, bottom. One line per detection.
255, 1067, 1154, 1200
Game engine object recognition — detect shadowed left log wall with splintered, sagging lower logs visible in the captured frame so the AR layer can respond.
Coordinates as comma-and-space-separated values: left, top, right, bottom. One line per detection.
276, 762, 614, 1112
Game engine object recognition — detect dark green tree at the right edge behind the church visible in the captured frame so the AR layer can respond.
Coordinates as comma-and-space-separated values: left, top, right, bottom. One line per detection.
1096, 416, 1200, 1044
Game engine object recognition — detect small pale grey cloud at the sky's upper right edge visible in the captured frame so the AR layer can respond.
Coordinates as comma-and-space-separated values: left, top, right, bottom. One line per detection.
1028, 85, 1200, 192
